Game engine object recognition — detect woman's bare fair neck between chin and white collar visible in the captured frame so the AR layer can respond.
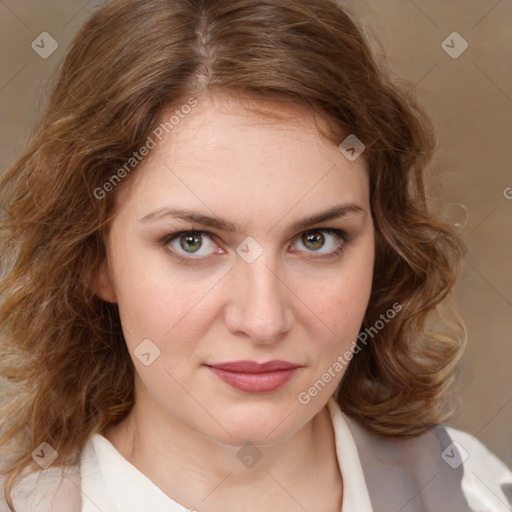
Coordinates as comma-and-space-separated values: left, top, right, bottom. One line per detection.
104, 394, 341, 511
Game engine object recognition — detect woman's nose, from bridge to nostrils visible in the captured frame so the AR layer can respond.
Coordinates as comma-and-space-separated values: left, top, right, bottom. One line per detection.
225, 255, 294, 344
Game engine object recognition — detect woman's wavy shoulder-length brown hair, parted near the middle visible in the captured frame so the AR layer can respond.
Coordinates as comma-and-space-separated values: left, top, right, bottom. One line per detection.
0, 0, 466, 508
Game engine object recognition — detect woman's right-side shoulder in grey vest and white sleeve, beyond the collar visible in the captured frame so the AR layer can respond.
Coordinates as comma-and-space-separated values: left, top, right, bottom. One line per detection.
336, 406, 512, 512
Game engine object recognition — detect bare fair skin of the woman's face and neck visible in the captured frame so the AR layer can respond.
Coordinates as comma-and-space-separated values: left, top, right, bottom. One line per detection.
95, 97, 375, 512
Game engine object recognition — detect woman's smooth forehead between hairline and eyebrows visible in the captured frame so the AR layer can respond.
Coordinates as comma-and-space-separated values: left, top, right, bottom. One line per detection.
113, 94, 368, 216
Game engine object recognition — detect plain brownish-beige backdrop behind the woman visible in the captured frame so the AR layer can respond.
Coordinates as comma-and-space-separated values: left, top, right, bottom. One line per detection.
0, 0, 512, 466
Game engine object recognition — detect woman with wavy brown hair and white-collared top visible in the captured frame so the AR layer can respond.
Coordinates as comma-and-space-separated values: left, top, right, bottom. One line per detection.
0, 0, 512, 512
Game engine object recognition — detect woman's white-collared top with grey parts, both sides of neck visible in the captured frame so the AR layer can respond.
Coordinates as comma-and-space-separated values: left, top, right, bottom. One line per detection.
4, 398, 512, 512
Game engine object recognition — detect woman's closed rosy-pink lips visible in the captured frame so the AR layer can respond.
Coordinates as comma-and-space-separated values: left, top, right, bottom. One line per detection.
206, 361, 300, 393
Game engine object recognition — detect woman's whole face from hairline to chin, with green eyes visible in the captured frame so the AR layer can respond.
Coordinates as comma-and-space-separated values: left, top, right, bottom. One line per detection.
97, 94, 374, 446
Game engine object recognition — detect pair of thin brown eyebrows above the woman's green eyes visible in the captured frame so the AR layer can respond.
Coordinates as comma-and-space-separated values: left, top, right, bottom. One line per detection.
139, 203, 366, 233
